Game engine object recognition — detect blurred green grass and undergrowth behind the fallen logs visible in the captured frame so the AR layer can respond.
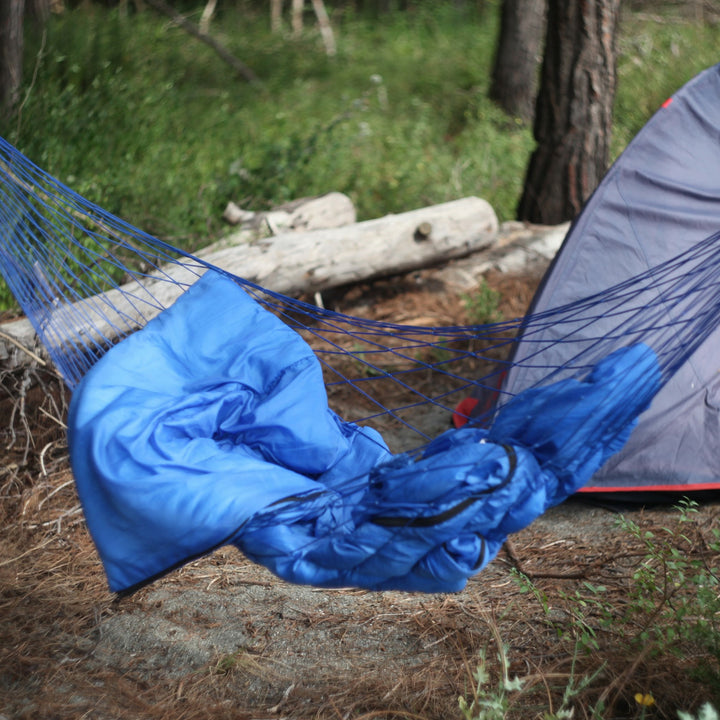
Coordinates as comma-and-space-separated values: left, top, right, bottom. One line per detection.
0, 0, 718, 312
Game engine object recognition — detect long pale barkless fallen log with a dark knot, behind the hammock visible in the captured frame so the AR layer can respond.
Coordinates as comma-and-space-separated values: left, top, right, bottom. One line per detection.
0, 197, 498, 367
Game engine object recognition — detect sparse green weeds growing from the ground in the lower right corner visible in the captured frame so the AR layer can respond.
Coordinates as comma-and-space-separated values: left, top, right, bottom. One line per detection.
459, 499, 720, 720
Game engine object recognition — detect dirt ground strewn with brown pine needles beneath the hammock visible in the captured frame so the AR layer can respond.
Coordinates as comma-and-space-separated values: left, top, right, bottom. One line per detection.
0, 264, 720, 720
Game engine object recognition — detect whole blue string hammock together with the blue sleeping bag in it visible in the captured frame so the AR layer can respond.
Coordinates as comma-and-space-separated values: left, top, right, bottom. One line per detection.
0, 134, 720, 592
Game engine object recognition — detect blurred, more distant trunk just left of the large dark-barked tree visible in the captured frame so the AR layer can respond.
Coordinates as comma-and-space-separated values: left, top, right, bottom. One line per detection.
489, 0, 546, 122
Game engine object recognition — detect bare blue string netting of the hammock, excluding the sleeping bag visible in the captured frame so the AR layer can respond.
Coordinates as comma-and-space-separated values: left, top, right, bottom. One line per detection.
0, 138, 720, 452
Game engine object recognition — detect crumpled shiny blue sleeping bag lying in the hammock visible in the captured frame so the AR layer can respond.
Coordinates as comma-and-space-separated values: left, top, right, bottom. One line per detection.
69, 271, 660, 592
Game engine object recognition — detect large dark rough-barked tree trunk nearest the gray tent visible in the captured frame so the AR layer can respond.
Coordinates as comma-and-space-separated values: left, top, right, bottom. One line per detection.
518, 0, 620, 225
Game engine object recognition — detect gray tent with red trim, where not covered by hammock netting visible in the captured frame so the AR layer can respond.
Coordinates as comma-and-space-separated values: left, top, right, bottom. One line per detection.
504, 65, 720, 499
